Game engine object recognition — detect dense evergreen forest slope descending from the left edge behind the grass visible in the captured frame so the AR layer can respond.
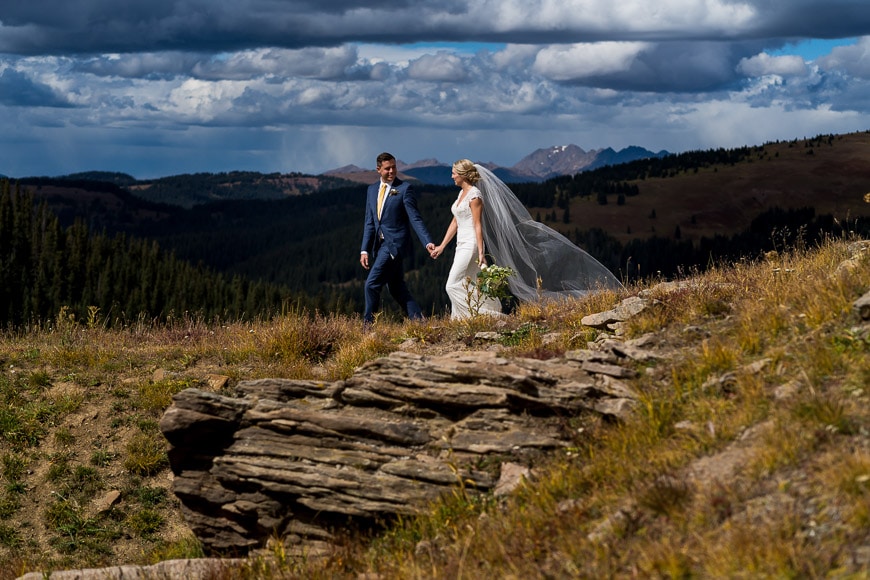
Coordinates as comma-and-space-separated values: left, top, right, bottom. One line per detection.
0, 181, 293, 326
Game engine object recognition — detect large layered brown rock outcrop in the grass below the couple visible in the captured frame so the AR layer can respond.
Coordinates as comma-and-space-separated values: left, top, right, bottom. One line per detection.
160, 343, 650, 553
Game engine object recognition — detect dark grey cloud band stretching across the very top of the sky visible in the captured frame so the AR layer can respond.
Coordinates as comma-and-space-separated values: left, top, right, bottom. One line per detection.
0, 0, 870, 55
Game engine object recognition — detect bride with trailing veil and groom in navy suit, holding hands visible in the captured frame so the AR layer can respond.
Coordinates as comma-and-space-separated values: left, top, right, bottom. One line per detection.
360, 153, 620, 327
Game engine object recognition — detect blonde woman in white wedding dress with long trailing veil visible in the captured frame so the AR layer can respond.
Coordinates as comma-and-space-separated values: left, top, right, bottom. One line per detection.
431, 159, 621, 318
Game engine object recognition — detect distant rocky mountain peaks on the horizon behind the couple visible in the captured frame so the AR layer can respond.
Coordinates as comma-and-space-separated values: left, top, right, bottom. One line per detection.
323, 145, 669, 185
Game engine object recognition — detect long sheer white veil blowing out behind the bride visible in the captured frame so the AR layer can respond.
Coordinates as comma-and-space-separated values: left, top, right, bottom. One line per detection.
475, 164, 622, 301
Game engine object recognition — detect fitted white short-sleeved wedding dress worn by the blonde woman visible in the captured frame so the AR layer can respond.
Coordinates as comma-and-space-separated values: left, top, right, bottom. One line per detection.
446, 187, 501, 319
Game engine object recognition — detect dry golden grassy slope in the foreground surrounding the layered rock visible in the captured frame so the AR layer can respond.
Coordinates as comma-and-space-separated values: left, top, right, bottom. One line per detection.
0, 233, 870, 579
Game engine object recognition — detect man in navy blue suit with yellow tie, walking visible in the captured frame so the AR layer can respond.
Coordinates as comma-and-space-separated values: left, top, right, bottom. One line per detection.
359, 153, 435, 328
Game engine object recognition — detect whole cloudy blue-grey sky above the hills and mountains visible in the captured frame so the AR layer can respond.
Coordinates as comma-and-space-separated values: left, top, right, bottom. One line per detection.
0, 0, 870, 178
